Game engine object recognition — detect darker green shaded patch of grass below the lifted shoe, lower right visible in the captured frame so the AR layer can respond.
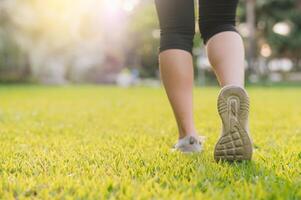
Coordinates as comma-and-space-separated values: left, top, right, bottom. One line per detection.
201, 161, 301, 199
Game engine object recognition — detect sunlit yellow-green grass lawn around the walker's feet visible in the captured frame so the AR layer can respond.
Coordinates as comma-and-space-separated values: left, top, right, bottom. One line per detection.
0, 86, 301, 200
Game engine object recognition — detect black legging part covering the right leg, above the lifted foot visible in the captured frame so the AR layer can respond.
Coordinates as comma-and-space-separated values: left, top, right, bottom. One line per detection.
199, 0, 238, 44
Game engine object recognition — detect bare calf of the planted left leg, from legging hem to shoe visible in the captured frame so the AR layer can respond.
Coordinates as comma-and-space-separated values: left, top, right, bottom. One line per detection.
160, 49, 196, 138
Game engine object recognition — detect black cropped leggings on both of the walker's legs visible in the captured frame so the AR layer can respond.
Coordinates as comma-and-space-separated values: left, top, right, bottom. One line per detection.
155, 0, 238, 53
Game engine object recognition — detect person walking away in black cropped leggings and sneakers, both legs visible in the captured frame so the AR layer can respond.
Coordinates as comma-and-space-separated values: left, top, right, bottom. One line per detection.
155, 0, 252, 161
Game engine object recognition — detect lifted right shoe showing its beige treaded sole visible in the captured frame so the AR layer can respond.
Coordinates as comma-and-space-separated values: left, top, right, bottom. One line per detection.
214, 86, 253, 162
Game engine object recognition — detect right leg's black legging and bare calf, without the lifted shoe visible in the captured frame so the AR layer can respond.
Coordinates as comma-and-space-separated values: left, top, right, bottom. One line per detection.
199, 0, 244, 87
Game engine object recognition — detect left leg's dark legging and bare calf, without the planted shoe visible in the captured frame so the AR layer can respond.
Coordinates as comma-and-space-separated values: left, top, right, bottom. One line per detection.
155, 0, 196, 138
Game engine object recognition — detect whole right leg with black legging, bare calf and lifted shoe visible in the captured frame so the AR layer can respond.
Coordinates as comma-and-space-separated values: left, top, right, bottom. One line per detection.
199, 0, 252, 161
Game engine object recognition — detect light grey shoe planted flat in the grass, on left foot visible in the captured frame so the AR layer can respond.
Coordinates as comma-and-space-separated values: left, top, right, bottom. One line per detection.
173, 135, 203, 153
